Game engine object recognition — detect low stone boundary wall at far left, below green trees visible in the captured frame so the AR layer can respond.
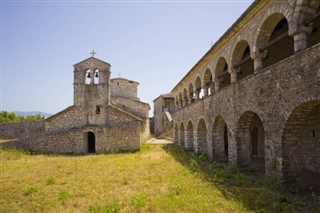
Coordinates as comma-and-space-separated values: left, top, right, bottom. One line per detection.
0, 121, 45, 139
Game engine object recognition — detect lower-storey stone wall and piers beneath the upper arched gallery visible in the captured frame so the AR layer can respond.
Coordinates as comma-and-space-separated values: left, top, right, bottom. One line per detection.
174, 42, 320, 175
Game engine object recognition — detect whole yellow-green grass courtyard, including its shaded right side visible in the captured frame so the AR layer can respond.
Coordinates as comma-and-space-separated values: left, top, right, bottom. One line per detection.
0, 141, 320, 213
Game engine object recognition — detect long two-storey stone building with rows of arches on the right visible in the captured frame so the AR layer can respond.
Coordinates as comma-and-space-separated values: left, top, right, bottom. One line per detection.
162, 0, 320, 187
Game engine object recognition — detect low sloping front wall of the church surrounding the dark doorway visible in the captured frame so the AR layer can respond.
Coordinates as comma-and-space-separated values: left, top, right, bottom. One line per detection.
1, 121, 141, 154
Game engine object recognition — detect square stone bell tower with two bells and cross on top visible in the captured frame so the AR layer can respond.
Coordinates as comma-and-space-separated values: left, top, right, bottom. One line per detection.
73, 51, 111, 125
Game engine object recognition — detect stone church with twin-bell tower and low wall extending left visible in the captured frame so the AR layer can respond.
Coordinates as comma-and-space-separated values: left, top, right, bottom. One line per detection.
0, 57, 150, 154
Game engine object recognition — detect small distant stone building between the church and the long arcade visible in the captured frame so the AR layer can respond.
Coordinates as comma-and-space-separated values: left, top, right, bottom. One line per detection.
153, 93, 175, 137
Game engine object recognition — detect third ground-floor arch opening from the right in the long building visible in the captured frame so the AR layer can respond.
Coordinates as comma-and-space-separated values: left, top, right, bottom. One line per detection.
212, 116, 229, 162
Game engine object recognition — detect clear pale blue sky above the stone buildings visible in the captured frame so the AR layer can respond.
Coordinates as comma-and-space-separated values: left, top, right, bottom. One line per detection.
0, 0, 253, 115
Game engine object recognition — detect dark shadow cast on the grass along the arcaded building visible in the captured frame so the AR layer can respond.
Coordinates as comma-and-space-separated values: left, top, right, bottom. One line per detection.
162, 145, 320, 212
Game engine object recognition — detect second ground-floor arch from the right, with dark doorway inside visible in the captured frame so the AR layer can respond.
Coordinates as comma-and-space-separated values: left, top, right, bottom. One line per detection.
236, 111, 265, 173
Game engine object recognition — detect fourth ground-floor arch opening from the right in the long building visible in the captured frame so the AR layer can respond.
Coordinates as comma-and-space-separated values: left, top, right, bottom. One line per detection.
195, 119, 208, 154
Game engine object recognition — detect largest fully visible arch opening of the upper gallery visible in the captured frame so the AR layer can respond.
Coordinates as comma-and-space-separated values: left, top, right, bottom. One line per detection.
256, 13, 294, 67
